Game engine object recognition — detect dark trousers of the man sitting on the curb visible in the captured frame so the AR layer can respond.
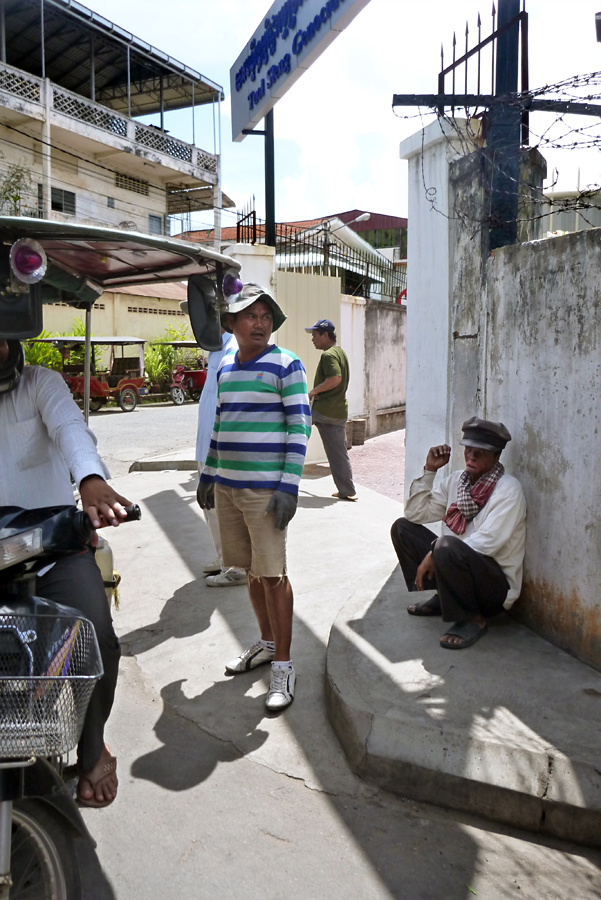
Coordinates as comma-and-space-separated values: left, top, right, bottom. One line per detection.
390, 519, 509, 622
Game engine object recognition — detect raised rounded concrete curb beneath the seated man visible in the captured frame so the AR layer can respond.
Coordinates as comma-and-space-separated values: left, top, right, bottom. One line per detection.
325, 586, 601, 847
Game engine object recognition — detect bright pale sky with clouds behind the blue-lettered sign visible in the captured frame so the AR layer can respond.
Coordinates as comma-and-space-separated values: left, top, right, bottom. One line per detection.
84, 0, 601, 227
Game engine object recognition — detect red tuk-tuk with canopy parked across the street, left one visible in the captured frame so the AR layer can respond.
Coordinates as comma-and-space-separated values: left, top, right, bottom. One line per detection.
32, 335, 148, 412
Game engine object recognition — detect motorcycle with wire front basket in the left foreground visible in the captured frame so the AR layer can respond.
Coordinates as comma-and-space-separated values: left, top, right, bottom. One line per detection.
0, 506, 140, 900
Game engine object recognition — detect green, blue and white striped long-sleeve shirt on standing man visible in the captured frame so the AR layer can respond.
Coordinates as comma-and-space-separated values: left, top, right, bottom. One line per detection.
201, 344, 311, 494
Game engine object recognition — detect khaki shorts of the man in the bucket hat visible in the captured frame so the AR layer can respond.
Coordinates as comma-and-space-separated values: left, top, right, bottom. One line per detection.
215, 484, 286, 578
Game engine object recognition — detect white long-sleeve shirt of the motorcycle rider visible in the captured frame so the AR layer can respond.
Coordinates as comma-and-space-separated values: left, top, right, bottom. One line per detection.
0, 366, 110, 509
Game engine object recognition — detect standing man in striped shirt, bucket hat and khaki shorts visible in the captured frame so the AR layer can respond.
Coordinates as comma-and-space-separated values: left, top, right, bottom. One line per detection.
198, 284, 311, 711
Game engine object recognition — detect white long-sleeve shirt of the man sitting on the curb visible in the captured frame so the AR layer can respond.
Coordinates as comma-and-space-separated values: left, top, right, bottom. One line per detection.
405, 469, 526, 609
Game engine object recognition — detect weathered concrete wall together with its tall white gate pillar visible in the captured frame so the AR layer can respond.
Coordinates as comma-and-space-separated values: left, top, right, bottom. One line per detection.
404, 118, 601, 668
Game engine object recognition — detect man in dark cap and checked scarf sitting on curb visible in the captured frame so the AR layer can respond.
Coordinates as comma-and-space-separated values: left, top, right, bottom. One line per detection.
391, 416, 526, 650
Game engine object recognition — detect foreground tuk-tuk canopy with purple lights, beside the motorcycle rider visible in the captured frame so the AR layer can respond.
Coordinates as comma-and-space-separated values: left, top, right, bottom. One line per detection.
0, 216, 240, 420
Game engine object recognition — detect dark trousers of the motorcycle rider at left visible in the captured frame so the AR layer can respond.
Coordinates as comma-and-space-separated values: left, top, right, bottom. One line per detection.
36, 551, 121, 772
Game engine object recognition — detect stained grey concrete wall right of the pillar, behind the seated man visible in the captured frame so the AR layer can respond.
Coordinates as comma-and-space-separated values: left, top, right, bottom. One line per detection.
484, 229, 601, 668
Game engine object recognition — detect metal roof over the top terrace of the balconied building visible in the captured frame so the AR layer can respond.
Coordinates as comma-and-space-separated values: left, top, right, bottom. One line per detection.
4, 0, 223, 116
